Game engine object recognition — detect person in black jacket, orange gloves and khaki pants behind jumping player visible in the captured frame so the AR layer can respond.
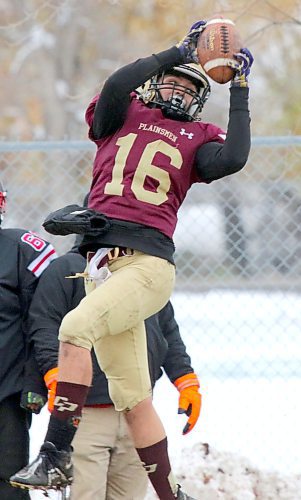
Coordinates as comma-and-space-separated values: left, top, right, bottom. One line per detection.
29, 246, 201, 500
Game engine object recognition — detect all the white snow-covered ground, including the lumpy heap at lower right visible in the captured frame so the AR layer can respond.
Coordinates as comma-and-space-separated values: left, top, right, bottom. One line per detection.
31, 292, 301, 500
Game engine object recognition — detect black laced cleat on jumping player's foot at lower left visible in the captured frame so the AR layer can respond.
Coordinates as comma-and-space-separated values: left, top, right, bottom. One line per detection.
10, 441, 73, 490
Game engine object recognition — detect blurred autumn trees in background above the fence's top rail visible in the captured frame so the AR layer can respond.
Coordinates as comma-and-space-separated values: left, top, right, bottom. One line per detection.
0, 0, 301, 139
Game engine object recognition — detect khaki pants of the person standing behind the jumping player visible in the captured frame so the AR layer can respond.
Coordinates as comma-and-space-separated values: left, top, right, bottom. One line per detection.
71, 406, 148, 500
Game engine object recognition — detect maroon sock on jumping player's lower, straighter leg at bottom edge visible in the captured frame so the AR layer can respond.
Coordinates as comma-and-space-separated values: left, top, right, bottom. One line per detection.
136, 438, 176, 500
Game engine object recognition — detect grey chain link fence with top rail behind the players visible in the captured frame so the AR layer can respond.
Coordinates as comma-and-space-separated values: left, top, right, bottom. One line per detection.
0, 137, 301, 472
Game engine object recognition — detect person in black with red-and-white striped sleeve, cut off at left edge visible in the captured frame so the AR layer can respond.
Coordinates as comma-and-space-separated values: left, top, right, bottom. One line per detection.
0, 182, 56, 500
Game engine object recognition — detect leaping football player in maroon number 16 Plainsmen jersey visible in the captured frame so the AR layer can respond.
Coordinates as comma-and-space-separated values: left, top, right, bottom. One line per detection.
12, 21, 253, 500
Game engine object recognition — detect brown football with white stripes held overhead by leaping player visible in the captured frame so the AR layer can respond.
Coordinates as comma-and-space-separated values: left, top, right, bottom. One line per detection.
197, 16, 242, 83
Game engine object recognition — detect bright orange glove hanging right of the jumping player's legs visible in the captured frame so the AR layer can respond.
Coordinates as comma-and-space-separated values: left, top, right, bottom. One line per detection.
174, 373, 202, 434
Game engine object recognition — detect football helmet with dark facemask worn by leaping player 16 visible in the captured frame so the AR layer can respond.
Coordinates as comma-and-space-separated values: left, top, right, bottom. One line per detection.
142, 64, 210, 121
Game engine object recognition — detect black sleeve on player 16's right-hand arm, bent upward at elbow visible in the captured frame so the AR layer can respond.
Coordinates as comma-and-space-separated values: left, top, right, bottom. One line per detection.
196, 87, 251, 182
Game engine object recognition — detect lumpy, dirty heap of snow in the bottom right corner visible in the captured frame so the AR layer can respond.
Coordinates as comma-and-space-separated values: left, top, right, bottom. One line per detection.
146, 443, 301, 500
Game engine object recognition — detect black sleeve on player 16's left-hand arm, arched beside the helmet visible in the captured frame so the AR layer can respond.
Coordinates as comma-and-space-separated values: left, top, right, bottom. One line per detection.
92, 47, 183, 140
